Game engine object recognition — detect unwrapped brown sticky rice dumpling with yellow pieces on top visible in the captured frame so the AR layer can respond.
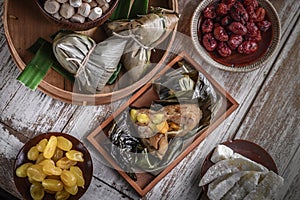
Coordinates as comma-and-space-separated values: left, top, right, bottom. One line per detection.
130, 104, 202, 160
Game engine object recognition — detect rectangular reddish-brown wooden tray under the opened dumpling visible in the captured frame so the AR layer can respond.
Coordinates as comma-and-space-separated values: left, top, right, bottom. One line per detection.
87, 52, 238, 196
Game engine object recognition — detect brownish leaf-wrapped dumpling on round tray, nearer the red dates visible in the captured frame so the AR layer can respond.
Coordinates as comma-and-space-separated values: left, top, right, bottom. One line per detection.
104, 11, 179, 82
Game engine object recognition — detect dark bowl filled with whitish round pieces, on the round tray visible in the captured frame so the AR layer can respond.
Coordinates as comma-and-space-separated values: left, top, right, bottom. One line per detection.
35, 0, 119, 31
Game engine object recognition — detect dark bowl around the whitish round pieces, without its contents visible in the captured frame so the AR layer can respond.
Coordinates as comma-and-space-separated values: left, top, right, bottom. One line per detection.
34, 0, 119, 31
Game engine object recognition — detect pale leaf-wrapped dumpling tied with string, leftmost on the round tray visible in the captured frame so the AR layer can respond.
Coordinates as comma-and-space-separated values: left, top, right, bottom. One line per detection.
53, 33, 127, 94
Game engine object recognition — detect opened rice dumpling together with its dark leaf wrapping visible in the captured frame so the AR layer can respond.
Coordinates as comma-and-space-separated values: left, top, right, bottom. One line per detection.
104, 61, 222, 175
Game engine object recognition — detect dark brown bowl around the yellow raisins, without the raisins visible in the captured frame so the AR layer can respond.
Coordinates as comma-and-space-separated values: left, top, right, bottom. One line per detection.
13, 132, 93, 200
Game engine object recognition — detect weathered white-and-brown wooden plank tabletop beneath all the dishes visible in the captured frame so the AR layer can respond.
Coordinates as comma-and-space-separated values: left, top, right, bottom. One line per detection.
0, 0, 300, 199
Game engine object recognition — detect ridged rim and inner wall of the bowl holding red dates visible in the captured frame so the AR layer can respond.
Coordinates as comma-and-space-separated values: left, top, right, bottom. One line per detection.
191, 0, 281, 72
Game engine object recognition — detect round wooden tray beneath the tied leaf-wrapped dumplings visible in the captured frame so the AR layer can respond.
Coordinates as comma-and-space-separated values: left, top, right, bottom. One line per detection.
3, 0, 178, 105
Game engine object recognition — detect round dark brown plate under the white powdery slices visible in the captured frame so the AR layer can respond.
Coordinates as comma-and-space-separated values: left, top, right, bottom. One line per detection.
200, 140, 278, 193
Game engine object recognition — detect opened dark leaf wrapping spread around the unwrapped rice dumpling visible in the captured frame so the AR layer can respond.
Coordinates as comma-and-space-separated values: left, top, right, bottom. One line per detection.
105, 61, 223, 174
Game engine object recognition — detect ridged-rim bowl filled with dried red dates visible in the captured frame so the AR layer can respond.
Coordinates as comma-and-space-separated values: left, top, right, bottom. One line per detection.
191, 0, 281, 72
